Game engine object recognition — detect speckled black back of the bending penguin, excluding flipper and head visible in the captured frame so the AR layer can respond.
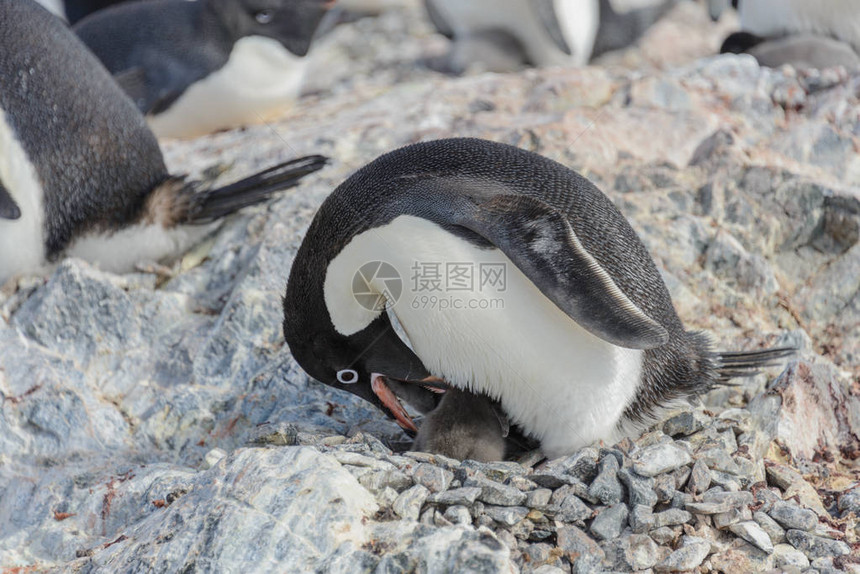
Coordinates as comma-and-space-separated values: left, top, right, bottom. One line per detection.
294, 138, 717, 426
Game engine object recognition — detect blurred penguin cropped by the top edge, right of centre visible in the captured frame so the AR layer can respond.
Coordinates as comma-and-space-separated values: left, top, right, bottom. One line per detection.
425, 0, 677, 73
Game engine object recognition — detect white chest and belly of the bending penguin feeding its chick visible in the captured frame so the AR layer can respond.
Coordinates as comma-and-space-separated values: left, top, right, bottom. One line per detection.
325, 215, 642, 456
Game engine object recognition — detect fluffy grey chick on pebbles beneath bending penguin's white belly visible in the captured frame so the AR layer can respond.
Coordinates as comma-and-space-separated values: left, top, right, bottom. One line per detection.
412, 389, 508, 462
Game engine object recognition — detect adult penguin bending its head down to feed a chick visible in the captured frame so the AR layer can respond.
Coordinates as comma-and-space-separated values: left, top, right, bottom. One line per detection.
283, 139, 788, 457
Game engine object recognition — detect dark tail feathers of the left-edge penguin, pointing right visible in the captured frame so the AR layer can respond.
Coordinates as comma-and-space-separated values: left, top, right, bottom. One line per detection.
182, 155, 328, 225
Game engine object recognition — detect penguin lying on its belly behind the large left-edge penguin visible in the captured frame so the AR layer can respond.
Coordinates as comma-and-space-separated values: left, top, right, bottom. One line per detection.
74, 0, 332, 137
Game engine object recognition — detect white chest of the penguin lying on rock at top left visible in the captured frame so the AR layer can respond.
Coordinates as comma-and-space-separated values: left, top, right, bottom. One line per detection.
148, 36, 307, 137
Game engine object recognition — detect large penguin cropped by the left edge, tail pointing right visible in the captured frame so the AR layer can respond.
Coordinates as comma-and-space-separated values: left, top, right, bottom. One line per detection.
0, 0, 325, 283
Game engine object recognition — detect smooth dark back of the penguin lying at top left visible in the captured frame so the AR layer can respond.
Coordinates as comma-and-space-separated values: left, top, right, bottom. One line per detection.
74, 0, 230, 113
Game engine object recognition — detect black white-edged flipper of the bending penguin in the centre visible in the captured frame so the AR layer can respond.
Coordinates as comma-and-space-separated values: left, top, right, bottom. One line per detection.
456, 195, 669, 349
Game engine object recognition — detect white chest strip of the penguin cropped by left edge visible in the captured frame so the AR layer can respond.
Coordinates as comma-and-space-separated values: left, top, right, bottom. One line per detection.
0, 109, 45, 285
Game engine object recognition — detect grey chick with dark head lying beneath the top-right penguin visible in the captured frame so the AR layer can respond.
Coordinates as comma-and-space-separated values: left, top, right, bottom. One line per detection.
720, 32, 860, 69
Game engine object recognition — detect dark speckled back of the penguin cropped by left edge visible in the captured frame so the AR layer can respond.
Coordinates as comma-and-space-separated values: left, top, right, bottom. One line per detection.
0, 0, 167, 258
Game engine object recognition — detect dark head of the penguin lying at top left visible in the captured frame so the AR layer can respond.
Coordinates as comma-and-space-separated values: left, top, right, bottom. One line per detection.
217, 0, 334, 56
